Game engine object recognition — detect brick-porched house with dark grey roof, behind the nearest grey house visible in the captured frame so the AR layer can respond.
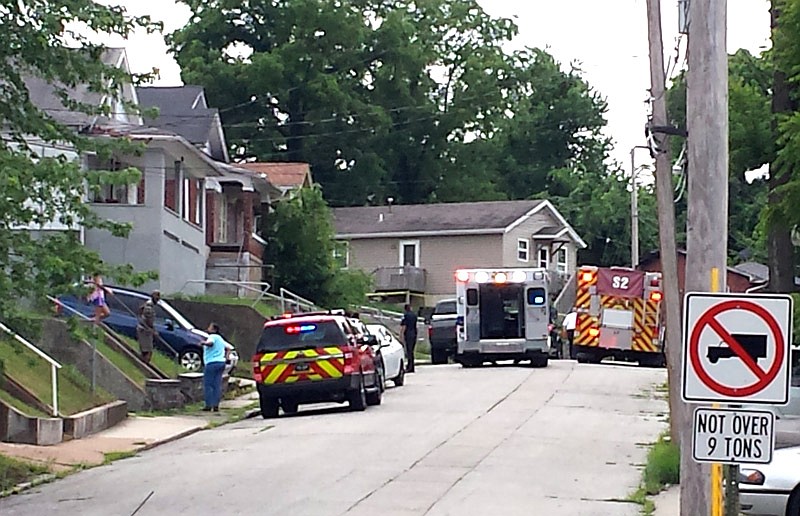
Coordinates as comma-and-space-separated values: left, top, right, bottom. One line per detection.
136, 86, 284, 296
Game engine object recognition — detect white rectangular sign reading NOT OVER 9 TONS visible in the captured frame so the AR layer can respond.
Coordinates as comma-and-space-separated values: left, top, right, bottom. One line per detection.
692, 407, 775, 464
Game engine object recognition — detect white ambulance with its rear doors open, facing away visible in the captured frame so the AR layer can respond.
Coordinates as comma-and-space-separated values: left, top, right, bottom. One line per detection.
455, 267, 551, 367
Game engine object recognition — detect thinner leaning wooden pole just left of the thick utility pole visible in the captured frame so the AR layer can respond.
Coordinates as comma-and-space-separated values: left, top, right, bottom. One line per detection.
644, 0, 689, 445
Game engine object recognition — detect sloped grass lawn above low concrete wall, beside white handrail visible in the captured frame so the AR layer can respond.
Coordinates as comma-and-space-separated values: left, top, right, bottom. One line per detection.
0, 338, 114, 414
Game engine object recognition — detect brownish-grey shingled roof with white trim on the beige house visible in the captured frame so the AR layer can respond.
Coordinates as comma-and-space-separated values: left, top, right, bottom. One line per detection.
333, 200, 586, 247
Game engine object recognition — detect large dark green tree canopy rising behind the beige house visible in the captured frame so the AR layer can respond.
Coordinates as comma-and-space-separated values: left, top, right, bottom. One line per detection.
169, 0, 636, 263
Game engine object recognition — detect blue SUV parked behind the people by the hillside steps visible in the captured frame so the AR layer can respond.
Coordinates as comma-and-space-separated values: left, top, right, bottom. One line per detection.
58, 286, 239, 373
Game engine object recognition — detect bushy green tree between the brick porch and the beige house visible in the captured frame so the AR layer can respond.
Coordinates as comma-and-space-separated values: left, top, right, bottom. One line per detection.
262, 188, 371, 308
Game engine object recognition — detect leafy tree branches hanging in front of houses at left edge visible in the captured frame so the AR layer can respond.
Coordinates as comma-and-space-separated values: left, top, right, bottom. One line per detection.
0, 0, 156, 320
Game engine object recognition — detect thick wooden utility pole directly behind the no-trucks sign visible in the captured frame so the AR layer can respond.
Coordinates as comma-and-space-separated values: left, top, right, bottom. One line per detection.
681, 0, 728, 516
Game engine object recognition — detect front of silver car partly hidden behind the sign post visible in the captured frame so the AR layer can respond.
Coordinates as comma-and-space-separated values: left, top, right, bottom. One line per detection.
739, 446, 800, 516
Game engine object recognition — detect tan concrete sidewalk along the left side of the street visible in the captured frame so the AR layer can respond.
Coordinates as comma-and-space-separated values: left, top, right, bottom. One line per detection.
0, 393, 258, 473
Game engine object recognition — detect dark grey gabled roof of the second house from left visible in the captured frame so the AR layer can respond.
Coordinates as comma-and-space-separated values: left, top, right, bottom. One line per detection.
136, 85, 228, 162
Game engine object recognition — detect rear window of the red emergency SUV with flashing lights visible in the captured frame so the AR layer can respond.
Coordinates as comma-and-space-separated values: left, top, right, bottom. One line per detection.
256, 321, 347, 353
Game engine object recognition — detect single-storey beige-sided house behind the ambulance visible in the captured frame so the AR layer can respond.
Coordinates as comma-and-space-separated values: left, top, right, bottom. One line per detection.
333, 200, 586, 305
